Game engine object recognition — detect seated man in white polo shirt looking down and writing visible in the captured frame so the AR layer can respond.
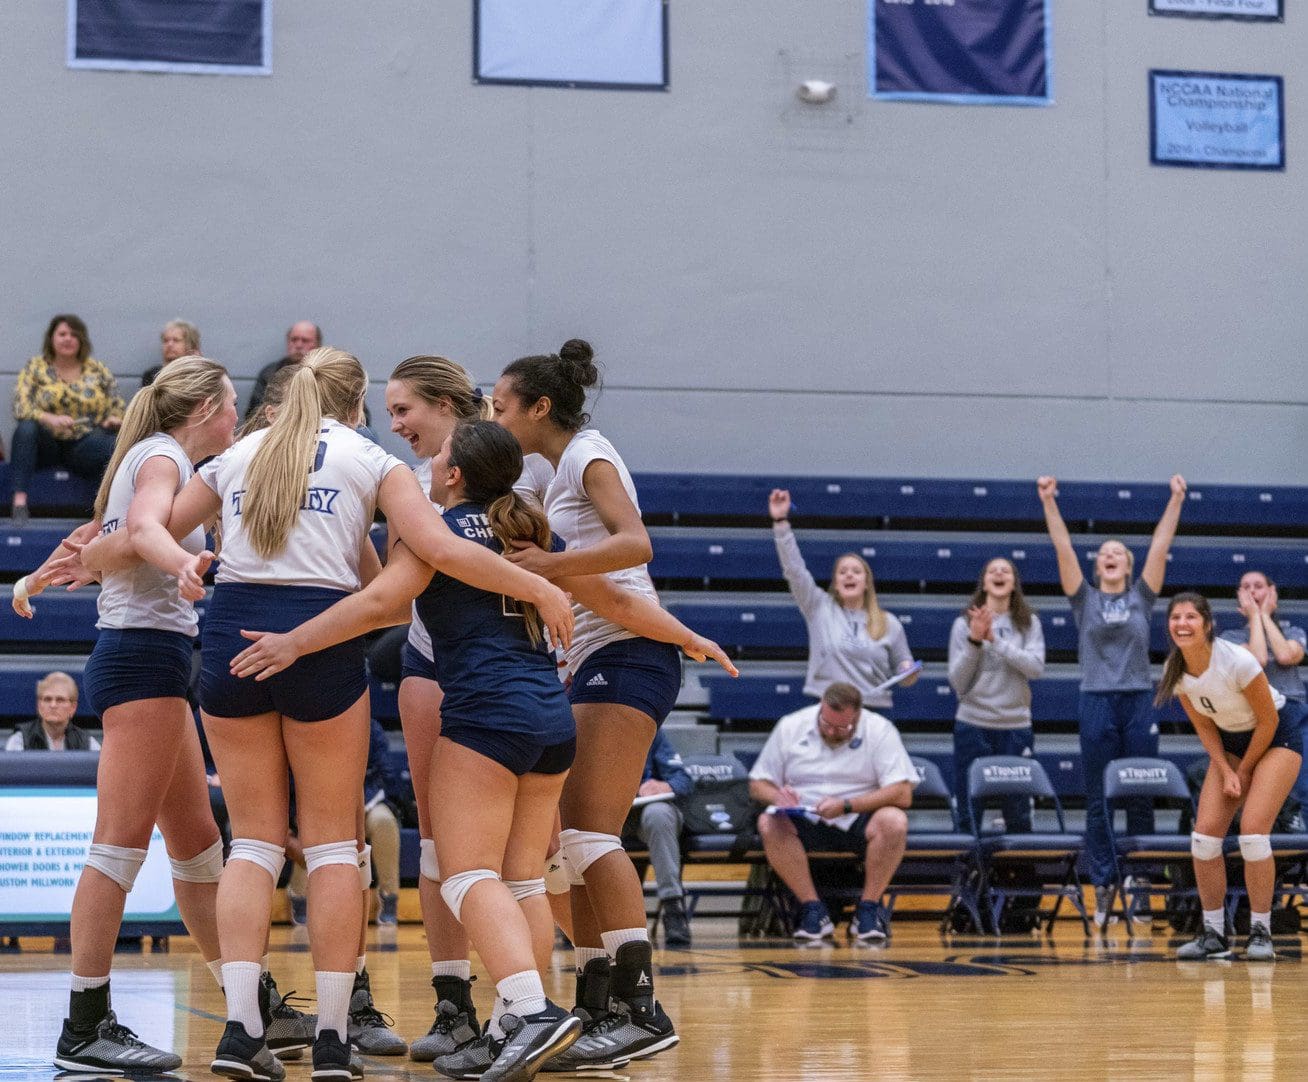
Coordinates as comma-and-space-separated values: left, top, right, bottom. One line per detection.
749, 683, 917, 943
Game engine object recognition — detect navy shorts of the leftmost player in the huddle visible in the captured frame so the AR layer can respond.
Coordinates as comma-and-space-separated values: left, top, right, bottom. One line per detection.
82, 628, 195, 717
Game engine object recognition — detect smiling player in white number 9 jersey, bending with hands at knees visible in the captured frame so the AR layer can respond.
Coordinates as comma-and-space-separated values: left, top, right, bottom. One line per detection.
1156, 593, 1303, 962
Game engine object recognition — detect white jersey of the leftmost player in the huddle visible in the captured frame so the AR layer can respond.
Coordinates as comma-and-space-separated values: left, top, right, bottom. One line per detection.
95, 432, 204, 635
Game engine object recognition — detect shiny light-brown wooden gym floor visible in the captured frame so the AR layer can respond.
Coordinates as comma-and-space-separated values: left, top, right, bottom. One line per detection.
0, 918, 1308, 1082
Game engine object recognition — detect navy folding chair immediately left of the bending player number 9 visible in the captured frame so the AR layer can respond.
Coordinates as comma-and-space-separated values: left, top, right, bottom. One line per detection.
1104, 758, 1198, 933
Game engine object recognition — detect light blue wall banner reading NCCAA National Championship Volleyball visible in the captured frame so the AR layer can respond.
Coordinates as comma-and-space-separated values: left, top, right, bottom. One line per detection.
1148, 71, 1286, 170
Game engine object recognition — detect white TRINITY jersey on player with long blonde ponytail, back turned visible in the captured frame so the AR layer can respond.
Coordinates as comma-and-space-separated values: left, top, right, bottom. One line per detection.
200, 417, 408, 593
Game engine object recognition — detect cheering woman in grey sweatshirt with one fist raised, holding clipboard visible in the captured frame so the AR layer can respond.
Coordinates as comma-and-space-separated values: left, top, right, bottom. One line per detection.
768, 488, 917, 714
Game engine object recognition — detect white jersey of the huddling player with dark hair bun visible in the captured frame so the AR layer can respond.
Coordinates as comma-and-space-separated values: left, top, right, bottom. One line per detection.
544, 429, 658, 672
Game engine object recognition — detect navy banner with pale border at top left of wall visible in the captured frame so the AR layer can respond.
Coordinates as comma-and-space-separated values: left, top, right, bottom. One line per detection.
68, 0, 272, 75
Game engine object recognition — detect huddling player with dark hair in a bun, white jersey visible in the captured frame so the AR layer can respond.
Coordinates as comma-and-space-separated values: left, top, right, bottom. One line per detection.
492, 339, 681, 1070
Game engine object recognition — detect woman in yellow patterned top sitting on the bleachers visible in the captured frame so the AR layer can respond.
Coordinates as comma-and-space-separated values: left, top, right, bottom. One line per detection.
12, 314, 124, 526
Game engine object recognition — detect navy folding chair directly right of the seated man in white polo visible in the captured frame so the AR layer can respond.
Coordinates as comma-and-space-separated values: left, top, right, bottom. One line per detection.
886, 755, 985, 932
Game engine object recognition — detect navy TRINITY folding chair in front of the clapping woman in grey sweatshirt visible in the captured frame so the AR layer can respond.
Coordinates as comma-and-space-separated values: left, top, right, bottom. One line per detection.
968, 755, 1090, 935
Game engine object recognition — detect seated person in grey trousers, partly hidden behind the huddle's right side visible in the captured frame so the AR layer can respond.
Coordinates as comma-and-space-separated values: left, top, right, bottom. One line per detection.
623, 729, 695, 947
